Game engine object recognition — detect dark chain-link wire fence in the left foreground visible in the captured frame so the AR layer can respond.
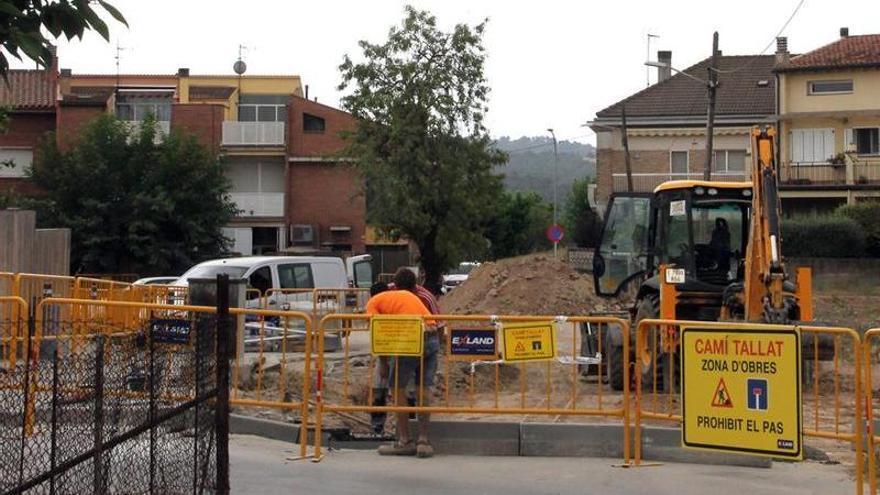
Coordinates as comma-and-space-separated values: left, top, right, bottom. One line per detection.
0, 298, 231, 494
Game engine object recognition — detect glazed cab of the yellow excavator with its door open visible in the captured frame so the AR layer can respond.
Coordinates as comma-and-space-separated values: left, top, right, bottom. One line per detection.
593, 180, 752, 320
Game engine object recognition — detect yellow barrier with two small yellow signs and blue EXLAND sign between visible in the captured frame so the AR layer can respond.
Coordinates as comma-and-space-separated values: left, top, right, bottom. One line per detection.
314, 314, 630, 462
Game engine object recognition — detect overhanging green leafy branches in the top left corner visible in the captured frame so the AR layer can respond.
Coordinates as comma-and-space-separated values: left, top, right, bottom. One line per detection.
0, 0, 128, 78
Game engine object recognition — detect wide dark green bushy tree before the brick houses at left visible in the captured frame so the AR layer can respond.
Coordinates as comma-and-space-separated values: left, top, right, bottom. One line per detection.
30, 116, 236, 275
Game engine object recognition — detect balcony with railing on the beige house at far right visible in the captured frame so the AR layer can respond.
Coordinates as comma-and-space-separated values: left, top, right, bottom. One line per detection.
779, 155, 880, 186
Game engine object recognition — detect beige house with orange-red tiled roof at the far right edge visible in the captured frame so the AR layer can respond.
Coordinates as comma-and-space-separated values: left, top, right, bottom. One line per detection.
776, 28, 880, 211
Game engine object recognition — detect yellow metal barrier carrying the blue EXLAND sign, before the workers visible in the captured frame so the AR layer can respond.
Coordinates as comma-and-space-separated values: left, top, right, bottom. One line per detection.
314, 314, 630, 461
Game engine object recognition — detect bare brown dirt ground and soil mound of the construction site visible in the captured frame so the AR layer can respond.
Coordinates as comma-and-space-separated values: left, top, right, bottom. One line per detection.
234, 254, 880, 480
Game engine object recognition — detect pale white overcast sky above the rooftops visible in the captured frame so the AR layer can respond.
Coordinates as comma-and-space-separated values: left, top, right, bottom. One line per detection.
15, 0, 880, 143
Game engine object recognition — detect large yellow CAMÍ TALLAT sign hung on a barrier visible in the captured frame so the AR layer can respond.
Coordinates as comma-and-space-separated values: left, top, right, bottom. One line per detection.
681, 327, 803, 459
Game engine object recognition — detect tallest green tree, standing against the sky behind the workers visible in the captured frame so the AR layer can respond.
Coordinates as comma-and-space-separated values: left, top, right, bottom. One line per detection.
339, 7, 505, 285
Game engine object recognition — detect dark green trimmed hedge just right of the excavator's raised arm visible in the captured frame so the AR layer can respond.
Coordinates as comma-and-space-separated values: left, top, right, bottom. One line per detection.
782, 215, 865, 258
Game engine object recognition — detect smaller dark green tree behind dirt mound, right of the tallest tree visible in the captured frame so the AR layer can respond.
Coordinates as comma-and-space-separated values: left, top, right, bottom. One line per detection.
486, 192, 553, 259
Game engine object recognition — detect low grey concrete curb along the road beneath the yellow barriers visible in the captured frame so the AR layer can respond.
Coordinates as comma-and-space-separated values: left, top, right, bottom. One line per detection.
229, 414, 772, 468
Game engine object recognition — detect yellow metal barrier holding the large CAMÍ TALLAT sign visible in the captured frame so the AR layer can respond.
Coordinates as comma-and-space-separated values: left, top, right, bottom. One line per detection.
633, 319, 864, 494
